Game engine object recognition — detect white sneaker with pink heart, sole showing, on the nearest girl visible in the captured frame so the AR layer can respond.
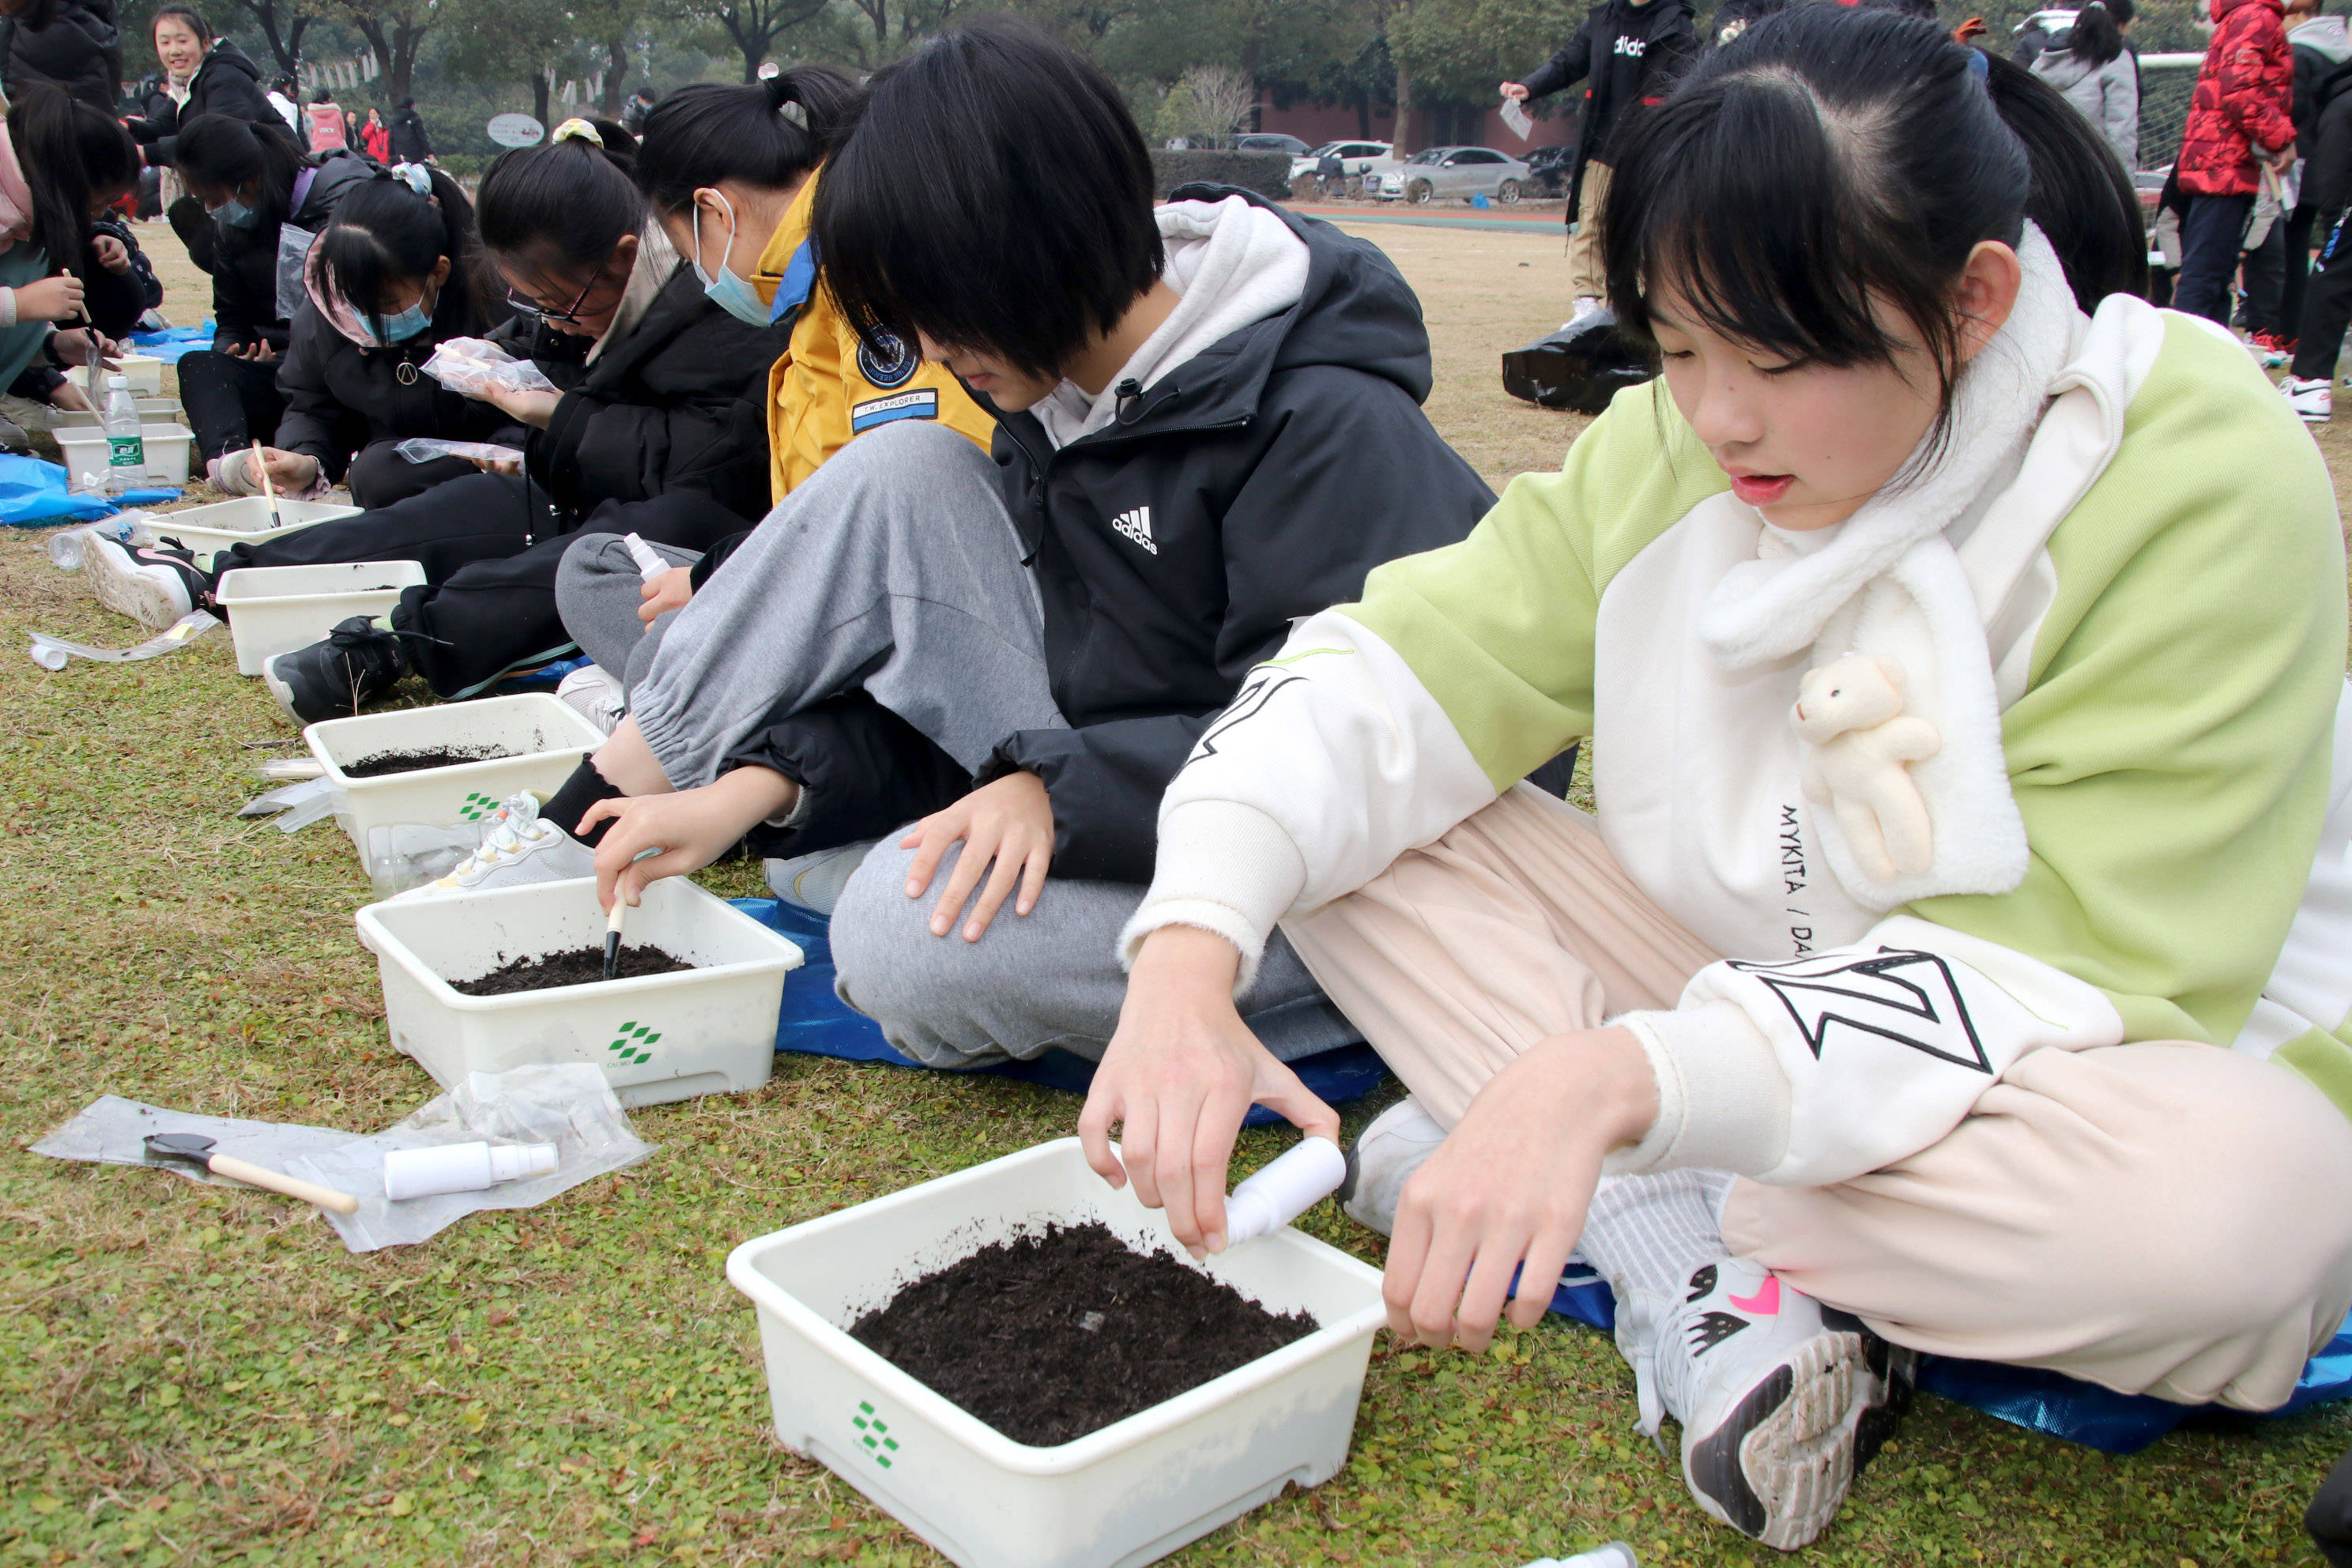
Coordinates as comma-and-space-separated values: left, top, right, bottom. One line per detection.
1616, 1257, 1917, 1551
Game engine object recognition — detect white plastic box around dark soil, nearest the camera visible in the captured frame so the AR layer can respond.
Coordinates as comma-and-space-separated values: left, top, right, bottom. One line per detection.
727, 1138, 1385, 1568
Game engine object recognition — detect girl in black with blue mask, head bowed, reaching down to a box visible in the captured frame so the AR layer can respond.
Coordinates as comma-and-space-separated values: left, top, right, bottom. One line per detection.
239, 174, 525, 507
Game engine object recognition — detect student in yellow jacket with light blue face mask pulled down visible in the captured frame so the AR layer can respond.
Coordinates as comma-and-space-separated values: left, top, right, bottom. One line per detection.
555, 66, 995, 729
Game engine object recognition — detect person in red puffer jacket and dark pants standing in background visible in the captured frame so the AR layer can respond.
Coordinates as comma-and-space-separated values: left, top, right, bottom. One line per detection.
2173, 0, 2296, 326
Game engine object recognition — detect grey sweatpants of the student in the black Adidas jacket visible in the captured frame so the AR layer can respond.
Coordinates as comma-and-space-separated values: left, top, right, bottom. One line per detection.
606, 420, 1359, 1067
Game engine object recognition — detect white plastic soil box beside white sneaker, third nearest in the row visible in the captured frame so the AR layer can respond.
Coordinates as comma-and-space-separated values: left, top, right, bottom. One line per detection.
301, 692, 605, 884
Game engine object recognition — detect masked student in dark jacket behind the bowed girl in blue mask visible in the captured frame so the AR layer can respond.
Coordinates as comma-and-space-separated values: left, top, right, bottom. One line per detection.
172, 111, 374, 469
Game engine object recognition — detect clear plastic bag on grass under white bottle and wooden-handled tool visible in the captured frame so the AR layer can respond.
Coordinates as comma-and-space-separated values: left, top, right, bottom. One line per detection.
33, 1062, 654, 1253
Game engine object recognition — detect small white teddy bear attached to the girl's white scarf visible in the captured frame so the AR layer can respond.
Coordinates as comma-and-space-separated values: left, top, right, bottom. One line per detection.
1790, 654, 1943, 881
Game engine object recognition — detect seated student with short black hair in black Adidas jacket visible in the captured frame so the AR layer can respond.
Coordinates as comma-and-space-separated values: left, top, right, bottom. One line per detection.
470, 24, 1494, 1065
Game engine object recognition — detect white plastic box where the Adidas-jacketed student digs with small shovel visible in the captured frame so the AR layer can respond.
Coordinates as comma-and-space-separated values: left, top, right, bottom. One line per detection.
360, 876, 800, 1107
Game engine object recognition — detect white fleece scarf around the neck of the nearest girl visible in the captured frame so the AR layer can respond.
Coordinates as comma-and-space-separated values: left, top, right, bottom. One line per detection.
1698, 224, 2077, 910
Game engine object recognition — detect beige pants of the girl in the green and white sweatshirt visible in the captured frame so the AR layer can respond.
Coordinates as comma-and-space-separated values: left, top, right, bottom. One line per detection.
1284, 785, 2352, 1411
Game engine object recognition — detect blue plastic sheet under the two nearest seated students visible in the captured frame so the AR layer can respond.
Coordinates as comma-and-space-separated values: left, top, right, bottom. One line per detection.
734, 898, 2352, 1453
